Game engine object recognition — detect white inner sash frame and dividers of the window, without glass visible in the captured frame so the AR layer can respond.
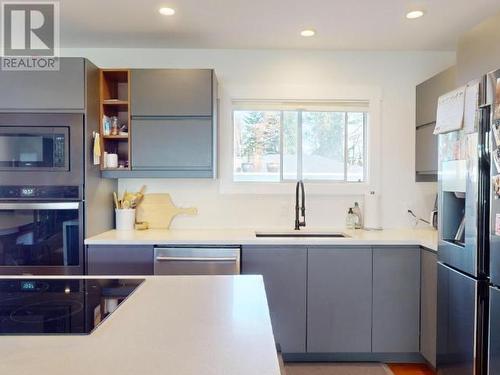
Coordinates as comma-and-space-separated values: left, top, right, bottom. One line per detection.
231, 105, 370, 185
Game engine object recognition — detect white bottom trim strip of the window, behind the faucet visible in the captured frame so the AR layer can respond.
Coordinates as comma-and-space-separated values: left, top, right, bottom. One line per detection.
219, 180, 370, 196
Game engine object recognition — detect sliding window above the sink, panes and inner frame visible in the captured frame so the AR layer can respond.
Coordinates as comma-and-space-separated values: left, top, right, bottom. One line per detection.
233, 102, 368, 183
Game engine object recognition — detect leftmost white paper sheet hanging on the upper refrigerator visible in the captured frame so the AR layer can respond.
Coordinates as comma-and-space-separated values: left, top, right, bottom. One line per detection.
434, 86, 466, 134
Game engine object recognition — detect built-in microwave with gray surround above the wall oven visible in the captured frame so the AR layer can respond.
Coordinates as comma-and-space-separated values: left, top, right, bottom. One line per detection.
0, 113, 84, 185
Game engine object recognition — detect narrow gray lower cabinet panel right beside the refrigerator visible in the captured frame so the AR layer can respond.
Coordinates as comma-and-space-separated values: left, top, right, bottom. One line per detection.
420, 248, 437, 367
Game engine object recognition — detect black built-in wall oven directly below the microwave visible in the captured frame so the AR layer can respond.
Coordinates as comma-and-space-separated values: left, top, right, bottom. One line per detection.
0, 185, 84, 275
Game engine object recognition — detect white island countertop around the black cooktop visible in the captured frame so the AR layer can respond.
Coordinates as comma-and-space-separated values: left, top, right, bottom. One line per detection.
0, 276, 280, 375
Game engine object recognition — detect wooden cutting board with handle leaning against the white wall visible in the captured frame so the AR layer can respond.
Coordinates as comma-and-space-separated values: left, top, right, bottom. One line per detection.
136, 193, 198, 229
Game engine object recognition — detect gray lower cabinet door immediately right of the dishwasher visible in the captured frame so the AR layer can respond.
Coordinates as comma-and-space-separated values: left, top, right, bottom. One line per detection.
241, 246, 307, 354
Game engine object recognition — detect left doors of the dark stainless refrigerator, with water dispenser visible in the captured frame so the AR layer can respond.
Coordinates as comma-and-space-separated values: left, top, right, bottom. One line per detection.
436, 77, 490, 375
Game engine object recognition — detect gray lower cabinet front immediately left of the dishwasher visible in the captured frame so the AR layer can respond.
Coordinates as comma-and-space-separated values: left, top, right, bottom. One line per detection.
86, 245, 153, 275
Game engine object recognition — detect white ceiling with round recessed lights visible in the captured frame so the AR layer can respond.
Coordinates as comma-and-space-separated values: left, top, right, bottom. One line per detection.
60, 0, 500, 50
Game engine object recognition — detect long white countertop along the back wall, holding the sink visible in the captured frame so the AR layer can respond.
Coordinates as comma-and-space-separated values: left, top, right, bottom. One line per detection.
85, 229, 438, 251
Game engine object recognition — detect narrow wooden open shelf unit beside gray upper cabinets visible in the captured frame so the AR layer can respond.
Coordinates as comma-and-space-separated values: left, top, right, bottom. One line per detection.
100, 69, 131, 171
